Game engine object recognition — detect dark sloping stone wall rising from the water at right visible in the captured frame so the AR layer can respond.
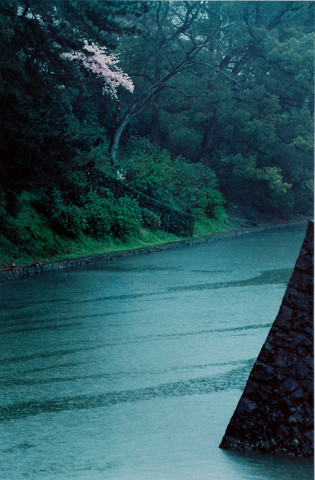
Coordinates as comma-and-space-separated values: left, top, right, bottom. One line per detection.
220, 222, 314, 456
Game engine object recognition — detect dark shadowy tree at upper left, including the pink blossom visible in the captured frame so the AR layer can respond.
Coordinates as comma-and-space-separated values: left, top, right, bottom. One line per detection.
0, 0, 145, 199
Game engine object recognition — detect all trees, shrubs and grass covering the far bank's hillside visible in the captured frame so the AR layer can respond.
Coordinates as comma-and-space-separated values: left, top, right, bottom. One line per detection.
0, 0, 314, 266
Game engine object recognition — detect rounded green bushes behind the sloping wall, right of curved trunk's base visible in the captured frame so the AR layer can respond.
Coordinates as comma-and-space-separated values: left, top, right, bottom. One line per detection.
121, 138, 224, 217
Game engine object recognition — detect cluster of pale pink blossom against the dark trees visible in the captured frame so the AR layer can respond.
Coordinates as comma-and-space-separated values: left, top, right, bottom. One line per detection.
63, 40, 134, 98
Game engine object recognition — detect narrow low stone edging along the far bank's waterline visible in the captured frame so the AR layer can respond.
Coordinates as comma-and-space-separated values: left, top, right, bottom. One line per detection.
0, 220, 307, 286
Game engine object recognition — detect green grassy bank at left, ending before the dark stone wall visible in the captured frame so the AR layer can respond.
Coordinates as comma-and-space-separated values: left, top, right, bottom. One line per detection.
0, 188, 185, 268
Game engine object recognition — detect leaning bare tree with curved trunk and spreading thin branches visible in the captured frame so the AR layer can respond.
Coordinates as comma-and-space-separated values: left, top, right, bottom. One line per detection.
110, 2, 237, 164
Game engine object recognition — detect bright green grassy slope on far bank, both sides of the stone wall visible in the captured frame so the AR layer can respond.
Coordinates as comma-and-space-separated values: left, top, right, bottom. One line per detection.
0, 195, 235, 268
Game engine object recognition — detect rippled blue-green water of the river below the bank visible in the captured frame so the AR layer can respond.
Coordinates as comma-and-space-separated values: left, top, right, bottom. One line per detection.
0, 227, 313, 480
